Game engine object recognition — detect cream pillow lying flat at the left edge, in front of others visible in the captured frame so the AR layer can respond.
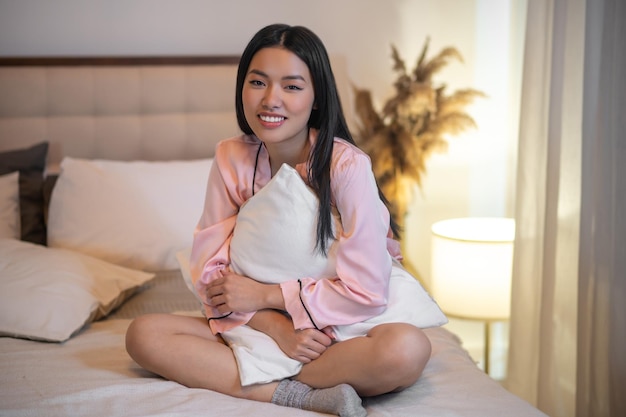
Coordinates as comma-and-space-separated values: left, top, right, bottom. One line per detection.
0, 239, 154, 342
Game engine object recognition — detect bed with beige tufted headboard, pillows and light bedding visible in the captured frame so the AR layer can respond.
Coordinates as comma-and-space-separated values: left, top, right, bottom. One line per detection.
0, 56, 545, 417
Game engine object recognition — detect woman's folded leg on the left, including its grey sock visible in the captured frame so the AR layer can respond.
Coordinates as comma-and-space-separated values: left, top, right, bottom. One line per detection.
126, 314, 366, 417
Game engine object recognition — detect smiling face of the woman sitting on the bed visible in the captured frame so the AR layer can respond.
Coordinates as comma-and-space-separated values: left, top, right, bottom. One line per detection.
241, 47, 315, 147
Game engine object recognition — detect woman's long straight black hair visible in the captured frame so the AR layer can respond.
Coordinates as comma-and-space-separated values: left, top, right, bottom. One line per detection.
235, 24, 398, 253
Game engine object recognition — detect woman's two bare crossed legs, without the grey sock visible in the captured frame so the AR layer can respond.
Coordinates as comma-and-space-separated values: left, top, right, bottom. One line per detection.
126, 314, 431, 402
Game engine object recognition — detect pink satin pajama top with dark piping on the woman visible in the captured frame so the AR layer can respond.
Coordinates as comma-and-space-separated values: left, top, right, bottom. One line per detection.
190, 130, 401, 334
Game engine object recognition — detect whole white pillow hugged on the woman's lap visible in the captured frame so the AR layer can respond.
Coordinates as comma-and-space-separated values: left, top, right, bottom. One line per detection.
218, 165, 448, 386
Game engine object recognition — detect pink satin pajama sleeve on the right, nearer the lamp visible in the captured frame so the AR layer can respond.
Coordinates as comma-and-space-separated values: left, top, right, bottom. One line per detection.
281, 143, 395, 329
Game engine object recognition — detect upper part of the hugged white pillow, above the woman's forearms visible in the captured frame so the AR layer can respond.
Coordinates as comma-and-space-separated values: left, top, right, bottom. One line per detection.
230, 164, 341, 284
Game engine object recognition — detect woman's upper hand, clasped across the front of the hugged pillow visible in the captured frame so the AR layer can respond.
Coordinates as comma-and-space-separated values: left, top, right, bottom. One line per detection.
206, 270, 285, 314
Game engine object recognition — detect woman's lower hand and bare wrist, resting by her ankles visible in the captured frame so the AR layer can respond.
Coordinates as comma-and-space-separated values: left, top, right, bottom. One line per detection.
248, 310, 332, 363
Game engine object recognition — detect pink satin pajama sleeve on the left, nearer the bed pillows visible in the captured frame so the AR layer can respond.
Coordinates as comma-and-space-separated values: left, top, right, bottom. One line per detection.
190, 140, 254, 334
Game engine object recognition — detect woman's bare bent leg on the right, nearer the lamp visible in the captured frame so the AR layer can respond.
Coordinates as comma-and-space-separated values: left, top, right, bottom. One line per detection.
297, 323, 431, 397
